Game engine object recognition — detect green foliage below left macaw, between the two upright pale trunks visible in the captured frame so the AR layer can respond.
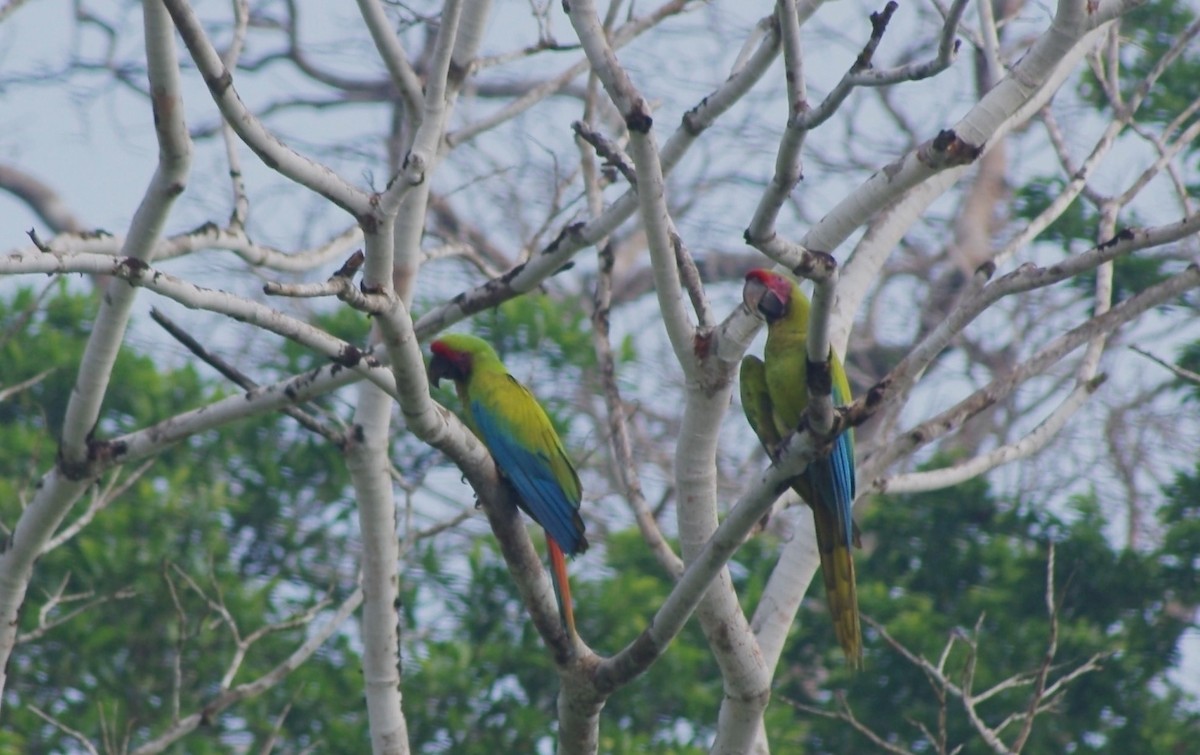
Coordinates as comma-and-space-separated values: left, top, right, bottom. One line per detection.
404, 531, 761, 755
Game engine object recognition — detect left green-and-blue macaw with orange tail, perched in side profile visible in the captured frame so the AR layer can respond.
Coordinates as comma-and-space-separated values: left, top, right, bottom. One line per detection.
430, 334, 588, 634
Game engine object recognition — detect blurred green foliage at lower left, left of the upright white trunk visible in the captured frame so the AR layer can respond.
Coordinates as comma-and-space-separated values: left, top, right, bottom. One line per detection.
0, 286, 366, 753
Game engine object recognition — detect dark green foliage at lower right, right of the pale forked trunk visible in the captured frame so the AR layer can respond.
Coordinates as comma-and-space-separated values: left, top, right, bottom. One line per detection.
778, 468, 1200, 754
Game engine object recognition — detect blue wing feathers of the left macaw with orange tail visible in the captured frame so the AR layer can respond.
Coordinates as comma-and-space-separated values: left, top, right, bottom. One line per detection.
470, 401, 583, 556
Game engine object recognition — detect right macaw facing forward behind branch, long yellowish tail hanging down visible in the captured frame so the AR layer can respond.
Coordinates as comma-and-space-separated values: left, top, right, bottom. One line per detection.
740, 270, 863, 669
